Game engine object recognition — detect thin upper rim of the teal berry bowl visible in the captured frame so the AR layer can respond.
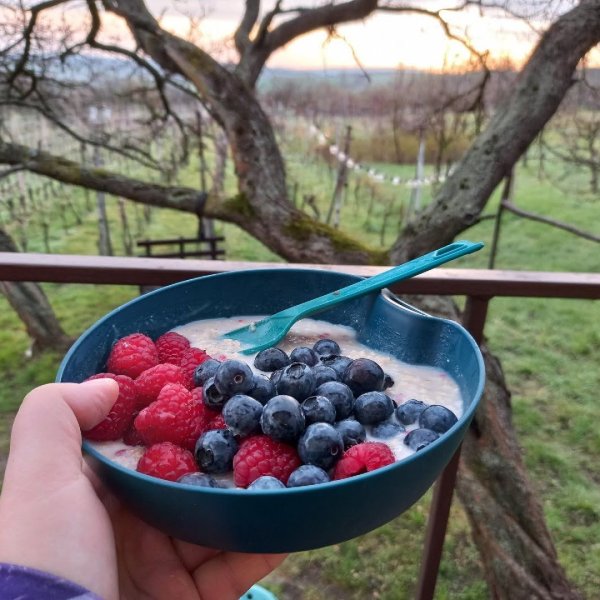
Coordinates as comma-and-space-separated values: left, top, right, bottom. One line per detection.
55, 267, 485, 497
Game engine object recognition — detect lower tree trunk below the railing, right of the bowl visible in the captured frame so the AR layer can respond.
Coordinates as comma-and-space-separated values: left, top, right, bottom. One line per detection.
406, 296, 582, 600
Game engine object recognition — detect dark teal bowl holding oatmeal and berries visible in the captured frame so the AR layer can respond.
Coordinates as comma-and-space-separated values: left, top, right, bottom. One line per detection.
57, 268, 484, 552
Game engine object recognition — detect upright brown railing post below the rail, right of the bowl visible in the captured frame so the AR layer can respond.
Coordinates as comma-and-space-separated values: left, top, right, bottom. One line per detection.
416, 296, 490, 600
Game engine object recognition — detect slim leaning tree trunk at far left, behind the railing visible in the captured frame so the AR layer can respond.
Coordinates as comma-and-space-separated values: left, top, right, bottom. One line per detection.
0, 229, 73, 354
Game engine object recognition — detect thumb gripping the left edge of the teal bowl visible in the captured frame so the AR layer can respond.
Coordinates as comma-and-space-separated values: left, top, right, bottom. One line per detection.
5, 379, 119, 485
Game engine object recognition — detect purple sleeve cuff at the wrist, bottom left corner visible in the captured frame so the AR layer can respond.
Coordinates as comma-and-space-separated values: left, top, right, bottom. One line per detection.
0, 563, 102, 600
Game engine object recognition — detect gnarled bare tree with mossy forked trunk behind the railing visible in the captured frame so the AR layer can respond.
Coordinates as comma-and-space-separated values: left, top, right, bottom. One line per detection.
0, 0, 600, 599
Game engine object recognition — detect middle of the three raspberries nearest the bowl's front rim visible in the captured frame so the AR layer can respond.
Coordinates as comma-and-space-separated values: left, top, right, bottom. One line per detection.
233, 435, 301, 487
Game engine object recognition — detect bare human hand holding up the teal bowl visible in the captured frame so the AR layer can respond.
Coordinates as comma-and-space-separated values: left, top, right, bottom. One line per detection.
0, 379, 284, 600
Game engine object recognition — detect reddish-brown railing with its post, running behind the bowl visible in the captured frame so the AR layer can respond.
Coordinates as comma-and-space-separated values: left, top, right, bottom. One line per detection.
0, 252, 600, 600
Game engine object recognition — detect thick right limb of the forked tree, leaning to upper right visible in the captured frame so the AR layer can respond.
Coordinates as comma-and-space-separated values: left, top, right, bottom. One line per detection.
391, 0, 600, 263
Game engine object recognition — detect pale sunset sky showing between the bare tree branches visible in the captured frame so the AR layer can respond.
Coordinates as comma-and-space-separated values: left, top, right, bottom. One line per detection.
52, 0, 600, 70
